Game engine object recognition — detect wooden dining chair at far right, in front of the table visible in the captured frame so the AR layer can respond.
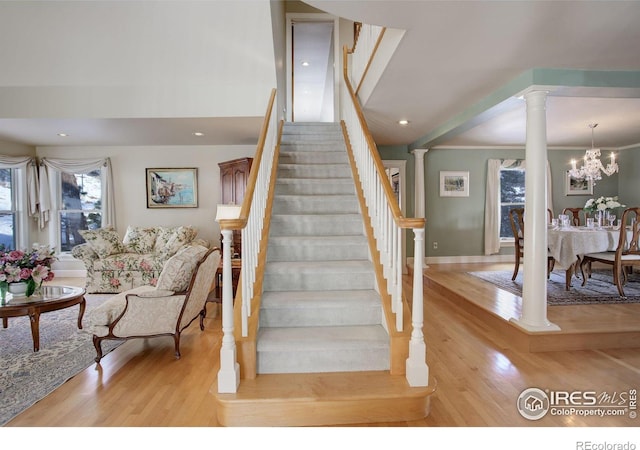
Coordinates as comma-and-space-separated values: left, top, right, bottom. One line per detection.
580, 207, 640, 298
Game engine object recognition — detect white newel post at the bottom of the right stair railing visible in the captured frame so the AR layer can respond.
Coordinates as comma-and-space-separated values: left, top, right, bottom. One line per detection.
406, 228, 429, 387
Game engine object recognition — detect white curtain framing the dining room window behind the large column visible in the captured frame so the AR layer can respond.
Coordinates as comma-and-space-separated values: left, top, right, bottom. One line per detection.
484, 159, 553, 255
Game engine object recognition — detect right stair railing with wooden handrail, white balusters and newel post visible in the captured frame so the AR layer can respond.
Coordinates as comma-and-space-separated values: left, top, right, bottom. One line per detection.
340, 37, 429, 386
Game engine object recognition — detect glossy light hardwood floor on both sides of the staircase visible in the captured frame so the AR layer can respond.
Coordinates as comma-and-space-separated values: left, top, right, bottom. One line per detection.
6, 264, 640, 428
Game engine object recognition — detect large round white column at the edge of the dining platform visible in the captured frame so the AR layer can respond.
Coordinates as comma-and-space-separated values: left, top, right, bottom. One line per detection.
514, 91, 560, 331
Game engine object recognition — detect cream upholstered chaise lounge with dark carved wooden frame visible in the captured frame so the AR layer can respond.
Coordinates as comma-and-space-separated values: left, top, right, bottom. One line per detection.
87, 246, 220, 363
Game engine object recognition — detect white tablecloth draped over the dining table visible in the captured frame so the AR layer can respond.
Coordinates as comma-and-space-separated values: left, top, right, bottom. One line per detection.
547, 227, 620, 270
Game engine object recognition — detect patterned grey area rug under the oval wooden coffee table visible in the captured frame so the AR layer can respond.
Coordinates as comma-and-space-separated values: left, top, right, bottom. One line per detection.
0, 294, 122, 426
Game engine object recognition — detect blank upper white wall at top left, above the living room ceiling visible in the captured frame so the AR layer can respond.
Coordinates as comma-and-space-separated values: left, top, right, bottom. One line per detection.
0, 0, 276, 118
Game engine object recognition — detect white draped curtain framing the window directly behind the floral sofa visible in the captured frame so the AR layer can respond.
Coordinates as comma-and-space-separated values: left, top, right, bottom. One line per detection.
39, 158, 116, 228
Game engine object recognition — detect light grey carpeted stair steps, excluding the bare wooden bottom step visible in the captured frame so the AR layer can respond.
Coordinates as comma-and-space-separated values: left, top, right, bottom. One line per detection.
257, 123, 389, 374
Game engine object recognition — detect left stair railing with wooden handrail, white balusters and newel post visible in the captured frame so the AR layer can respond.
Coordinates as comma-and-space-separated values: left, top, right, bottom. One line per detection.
218, 89, 278, 393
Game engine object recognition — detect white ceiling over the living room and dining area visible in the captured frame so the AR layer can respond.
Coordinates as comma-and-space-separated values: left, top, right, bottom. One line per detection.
0, 0, 640, 149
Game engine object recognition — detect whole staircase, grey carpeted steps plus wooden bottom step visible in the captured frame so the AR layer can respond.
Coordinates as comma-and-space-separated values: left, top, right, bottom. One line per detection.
211, 123, 435, 426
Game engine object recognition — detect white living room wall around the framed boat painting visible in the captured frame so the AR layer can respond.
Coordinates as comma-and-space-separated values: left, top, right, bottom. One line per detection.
33, 145, 256, 268
